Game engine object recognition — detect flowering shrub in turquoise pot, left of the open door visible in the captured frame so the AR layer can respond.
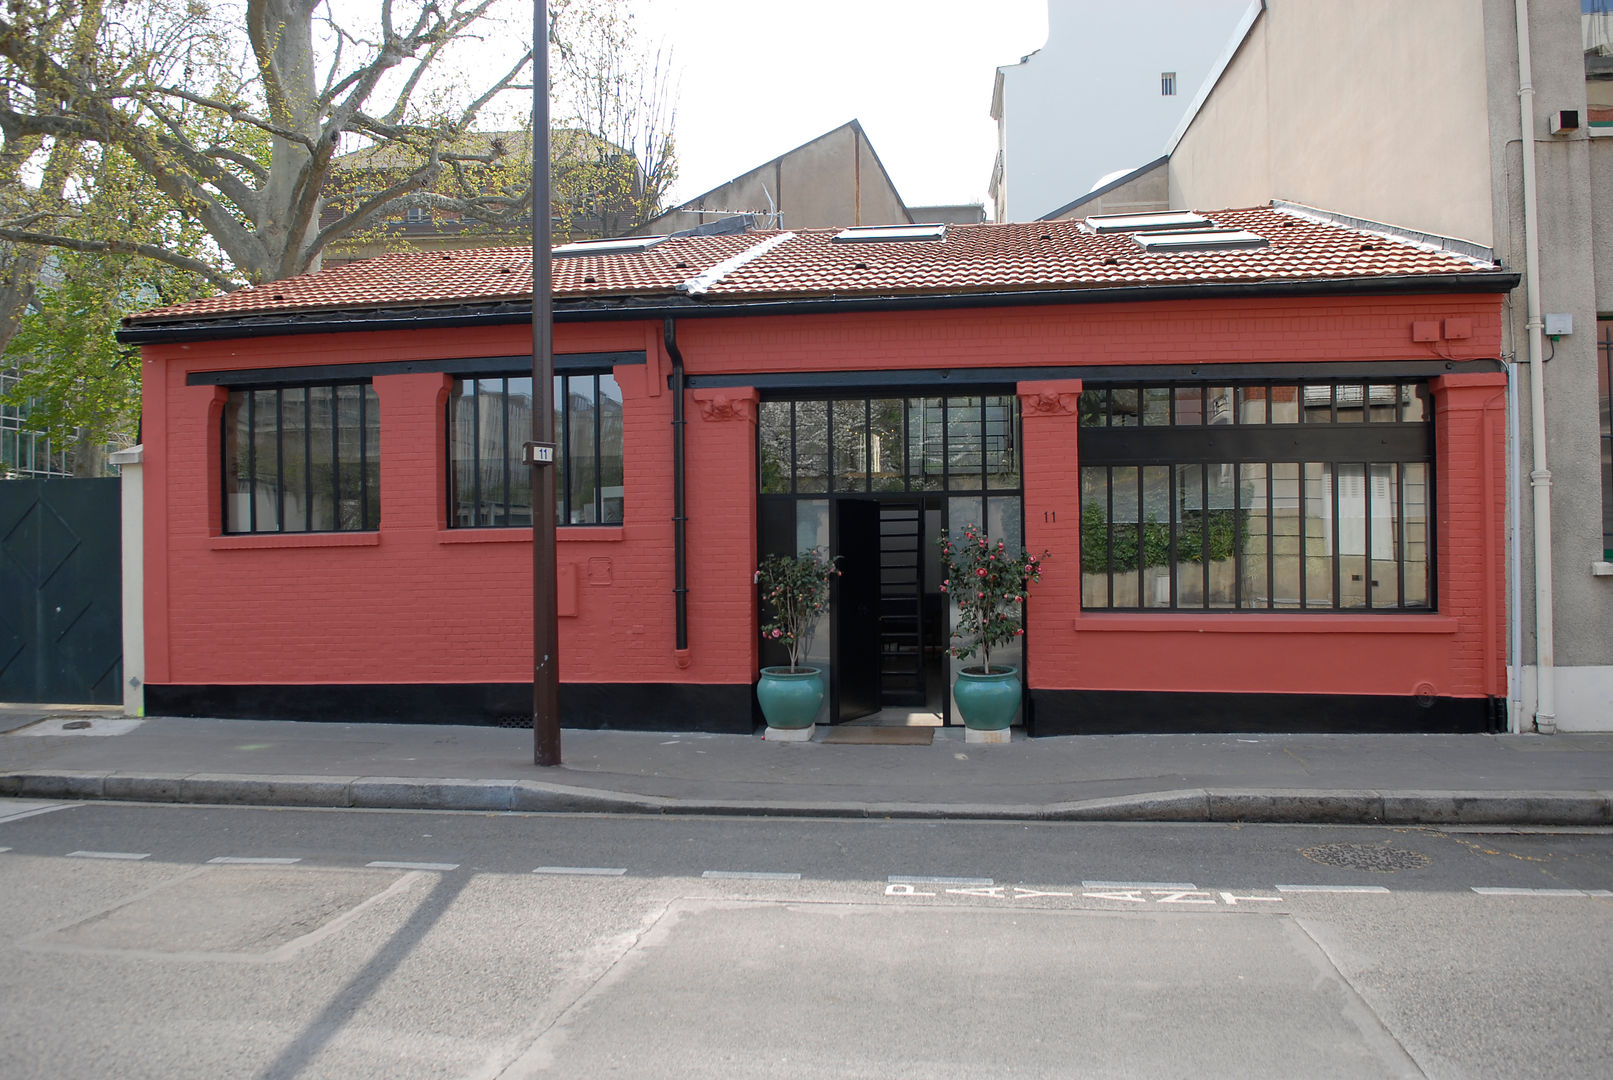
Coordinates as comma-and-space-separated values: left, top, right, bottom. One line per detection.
756, 548, 840, 740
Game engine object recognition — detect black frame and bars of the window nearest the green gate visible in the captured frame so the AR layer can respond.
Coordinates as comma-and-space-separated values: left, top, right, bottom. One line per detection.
218, 379, 381, 537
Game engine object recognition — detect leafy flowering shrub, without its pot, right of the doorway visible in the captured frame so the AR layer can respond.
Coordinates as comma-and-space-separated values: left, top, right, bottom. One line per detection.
936, 525, 1050, 674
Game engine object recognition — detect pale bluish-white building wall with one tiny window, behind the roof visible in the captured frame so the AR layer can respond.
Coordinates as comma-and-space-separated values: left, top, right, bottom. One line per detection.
992, 0, 1248, 221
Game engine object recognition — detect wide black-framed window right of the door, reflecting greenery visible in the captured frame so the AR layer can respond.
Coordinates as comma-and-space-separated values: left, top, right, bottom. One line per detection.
1079, 380, 1436, 611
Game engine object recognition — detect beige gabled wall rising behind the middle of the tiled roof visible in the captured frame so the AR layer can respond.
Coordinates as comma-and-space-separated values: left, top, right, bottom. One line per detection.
636, 121, 911, 235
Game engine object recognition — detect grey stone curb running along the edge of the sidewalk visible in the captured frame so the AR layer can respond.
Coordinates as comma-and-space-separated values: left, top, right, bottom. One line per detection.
0, 771, 1613, 825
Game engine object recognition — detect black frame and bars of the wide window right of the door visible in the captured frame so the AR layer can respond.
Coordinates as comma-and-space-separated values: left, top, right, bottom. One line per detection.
1077, 376, 1439, 616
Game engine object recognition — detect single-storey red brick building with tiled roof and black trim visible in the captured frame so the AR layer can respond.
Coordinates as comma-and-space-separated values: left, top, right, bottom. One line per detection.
123, 208, 1516, 733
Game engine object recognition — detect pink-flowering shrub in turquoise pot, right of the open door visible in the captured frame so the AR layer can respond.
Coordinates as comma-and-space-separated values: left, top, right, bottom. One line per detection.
937, 525, 1048, 741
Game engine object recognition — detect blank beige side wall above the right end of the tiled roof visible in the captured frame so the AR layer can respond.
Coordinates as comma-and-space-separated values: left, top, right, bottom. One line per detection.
1171, 0, 1490, 247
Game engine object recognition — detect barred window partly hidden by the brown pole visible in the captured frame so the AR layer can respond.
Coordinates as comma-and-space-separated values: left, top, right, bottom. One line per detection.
448, 372, 624, 529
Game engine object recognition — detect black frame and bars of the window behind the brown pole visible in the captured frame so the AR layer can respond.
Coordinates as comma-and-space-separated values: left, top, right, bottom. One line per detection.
444, 366, 627, 529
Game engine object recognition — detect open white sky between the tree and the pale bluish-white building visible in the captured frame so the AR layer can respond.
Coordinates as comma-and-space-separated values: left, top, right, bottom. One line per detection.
634, 0, 1047, 206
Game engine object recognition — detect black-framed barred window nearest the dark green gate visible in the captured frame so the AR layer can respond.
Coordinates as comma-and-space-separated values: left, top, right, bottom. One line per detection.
219, 382, 381, 534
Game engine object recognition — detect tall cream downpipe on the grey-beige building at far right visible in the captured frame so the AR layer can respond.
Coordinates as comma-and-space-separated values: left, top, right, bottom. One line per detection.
1515, 0, 1557, 735
